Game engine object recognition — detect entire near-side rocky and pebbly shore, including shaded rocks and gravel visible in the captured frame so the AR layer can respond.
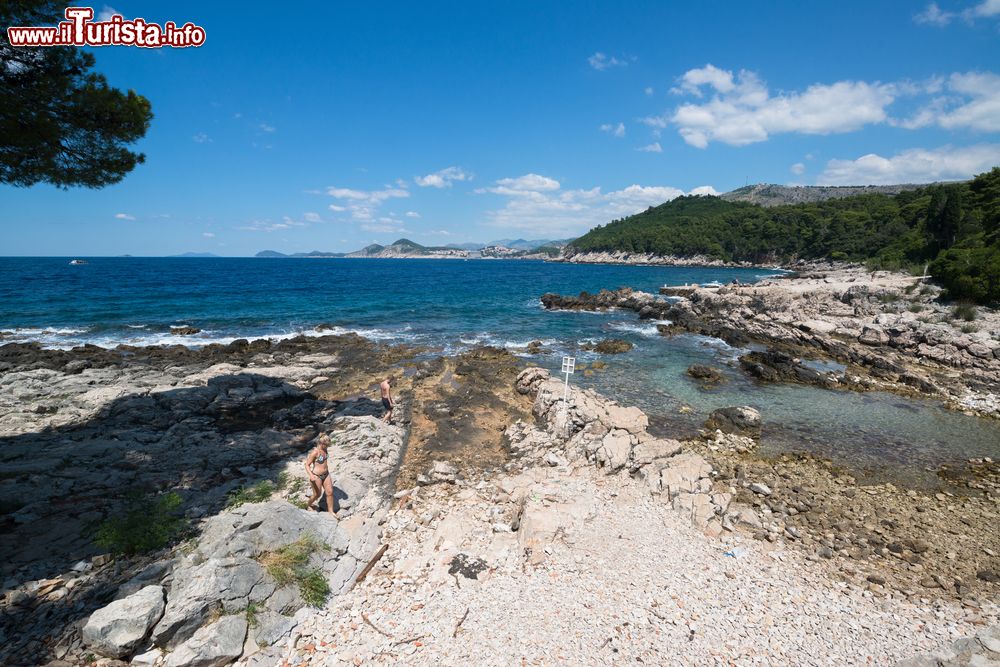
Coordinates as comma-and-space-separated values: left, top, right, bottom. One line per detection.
0, 320, 1000, 667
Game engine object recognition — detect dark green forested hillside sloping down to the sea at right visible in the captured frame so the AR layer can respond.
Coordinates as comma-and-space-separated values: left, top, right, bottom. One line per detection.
567, 167, 1000, 303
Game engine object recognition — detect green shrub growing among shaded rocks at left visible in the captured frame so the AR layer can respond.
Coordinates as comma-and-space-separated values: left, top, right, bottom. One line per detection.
94, 492, 187, 556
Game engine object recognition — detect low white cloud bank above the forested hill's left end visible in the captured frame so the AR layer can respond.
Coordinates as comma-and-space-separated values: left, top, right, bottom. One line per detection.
476, 174, 715, 238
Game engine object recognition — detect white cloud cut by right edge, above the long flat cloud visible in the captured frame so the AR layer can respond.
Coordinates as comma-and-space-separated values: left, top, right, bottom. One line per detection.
897, 71, 1000, 132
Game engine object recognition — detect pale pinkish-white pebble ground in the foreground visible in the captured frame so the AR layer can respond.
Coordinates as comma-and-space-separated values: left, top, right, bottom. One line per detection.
264, 468, 997, 665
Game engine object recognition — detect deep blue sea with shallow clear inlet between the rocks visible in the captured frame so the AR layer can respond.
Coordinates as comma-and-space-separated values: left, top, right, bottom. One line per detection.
0, 257, 1000, 481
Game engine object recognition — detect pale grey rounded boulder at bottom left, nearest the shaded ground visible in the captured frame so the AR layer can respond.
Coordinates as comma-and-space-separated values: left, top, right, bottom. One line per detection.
82, 586, 165, 658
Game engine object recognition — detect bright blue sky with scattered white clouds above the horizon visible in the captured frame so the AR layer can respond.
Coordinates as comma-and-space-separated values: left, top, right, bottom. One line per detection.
0, 0, 1000, 255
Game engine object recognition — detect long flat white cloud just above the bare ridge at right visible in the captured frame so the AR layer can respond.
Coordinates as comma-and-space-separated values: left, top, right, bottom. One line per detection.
818, 144, 1000, 185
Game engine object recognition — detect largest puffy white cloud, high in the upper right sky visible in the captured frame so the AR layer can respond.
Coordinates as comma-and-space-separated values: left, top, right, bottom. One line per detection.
668, 65, 896, 148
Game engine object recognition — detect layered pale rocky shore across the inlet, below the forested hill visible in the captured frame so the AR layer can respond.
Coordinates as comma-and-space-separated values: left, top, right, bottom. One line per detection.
541, 267, 1000, 417
